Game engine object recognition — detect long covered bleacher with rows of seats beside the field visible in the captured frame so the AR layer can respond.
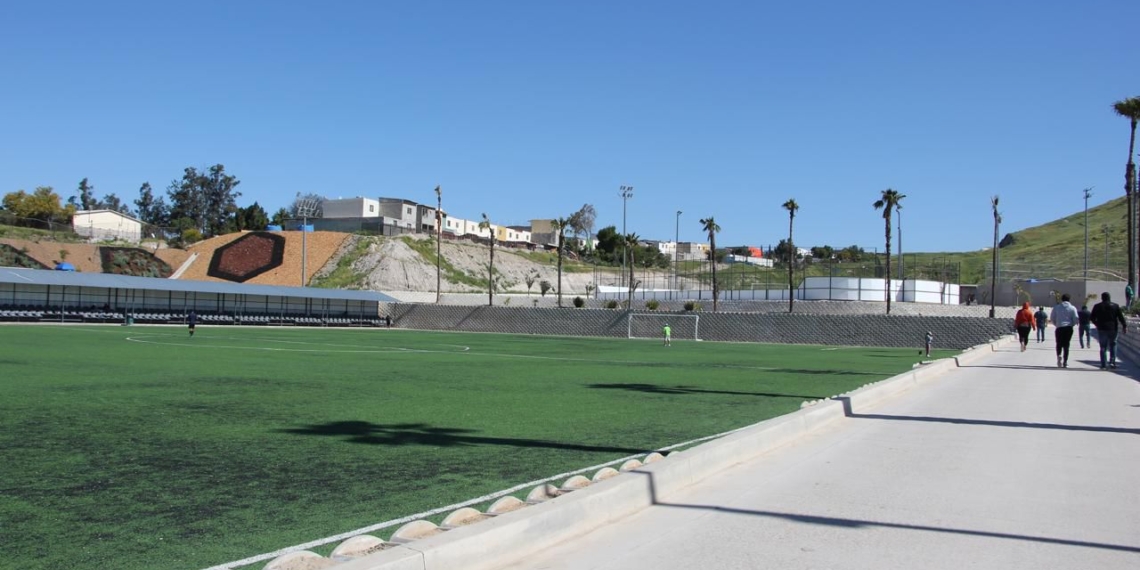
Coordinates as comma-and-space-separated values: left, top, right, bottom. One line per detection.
0, 267, 396, 326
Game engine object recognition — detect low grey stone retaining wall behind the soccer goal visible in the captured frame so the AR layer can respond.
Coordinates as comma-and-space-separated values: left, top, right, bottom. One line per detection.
381, 303, 1012, 350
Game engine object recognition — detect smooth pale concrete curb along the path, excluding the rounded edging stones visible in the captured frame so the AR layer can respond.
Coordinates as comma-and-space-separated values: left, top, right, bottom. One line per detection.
273, 337, 998, 570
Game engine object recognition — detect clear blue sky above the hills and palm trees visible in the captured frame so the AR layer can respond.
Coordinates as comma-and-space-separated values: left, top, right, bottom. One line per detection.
0, 0, 1140, 251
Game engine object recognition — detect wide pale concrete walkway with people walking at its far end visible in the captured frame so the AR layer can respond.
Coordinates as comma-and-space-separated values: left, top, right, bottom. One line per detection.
507, 335, 1140, 570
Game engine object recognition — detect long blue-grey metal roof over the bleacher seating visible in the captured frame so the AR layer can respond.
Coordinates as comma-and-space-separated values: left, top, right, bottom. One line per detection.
0, 267, 397, 303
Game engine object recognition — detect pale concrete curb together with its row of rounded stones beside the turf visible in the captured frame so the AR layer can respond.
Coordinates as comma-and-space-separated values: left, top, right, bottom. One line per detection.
254, 336, 1012, 570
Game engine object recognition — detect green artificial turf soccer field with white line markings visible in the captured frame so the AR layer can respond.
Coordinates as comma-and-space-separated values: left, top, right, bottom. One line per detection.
0, 325, 954, 570
